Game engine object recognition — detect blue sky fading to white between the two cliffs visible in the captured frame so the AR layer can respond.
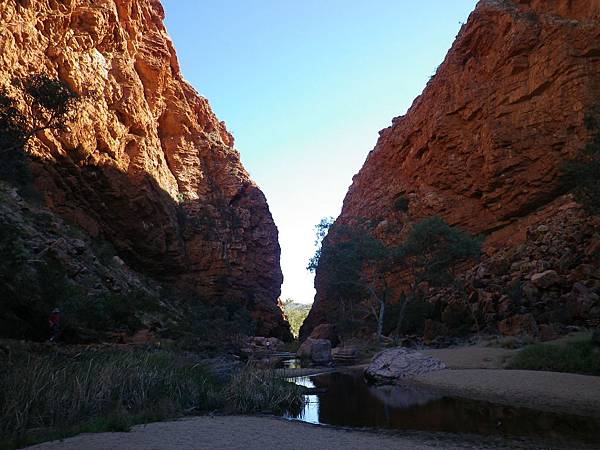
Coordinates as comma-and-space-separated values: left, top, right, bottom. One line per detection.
163, 0, 476, 303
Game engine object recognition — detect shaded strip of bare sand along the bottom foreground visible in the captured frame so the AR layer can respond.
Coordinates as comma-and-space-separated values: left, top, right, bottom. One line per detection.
30, 416, 532, 450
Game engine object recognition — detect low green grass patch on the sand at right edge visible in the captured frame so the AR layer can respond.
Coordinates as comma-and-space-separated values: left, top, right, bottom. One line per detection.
509, 340, 600, 376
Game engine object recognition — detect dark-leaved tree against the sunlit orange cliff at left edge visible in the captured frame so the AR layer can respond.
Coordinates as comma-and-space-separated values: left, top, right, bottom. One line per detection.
0, 75, 80, 192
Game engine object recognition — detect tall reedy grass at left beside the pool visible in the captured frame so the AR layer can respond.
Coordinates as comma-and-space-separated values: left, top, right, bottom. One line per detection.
0, 350, 303, 449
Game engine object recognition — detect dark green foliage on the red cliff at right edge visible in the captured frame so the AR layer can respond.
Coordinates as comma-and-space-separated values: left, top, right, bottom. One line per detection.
562, 110, 600, 214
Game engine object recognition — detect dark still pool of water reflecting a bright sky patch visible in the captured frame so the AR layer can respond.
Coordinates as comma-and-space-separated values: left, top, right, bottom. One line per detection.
288, 371, 600, 443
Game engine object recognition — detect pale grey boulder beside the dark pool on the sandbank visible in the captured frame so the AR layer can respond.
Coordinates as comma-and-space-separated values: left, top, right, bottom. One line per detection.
365, 347, 446, 384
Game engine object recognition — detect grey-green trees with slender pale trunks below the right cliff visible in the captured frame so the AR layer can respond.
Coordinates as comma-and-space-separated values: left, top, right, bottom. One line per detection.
308, 217, 481, 338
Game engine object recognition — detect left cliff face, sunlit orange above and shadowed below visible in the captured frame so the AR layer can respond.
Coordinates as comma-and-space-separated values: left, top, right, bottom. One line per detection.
0, 0, 289, 336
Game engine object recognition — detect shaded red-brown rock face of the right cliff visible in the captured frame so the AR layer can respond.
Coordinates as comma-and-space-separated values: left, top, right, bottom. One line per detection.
303, 0, 600, 334
